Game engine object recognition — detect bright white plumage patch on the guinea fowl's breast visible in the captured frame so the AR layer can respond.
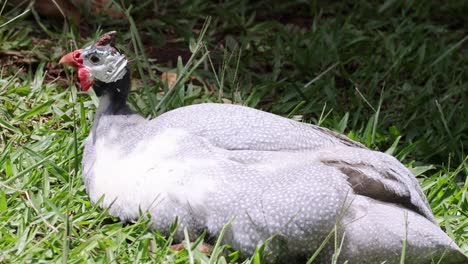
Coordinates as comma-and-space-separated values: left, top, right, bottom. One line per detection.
84, 129, 217, 219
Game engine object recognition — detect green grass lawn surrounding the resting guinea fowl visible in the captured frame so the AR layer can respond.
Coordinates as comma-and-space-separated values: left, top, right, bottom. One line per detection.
0, 1, 468, 263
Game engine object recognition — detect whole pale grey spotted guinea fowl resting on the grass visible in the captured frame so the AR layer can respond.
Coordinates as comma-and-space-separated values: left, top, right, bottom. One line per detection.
60, 32, 467, 263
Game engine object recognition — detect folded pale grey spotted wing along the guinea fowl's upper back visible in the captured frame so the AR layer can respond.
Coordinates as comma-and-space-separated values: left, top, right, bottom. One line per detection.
157, 104, 435, 223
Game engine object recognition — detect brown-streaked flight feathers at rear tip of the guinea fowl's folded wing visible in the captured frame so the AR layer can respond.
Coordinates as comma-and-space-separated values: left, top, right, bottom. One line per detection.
320, 147, 437, 224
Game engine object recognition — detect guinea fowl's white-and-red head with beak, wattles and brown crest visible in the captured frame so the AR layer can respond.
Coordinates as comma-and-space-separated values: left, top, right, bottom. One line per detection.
59, 31, 128, 91
